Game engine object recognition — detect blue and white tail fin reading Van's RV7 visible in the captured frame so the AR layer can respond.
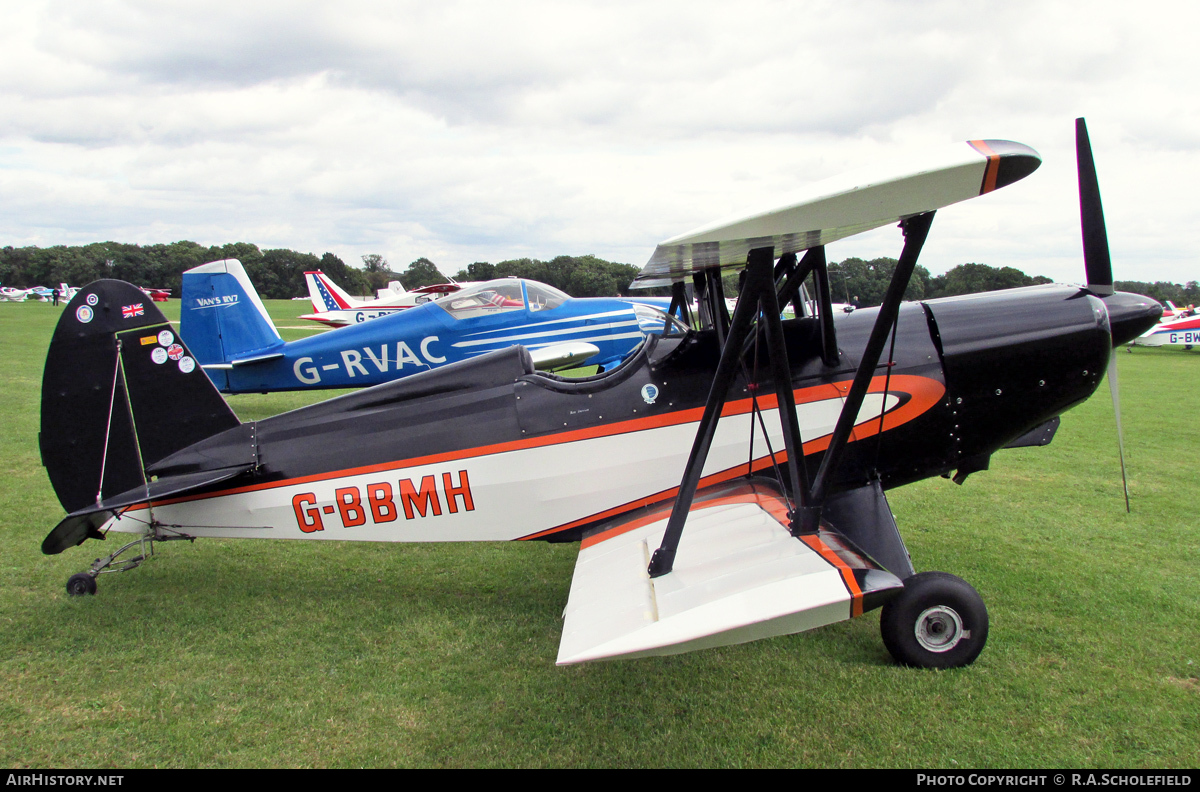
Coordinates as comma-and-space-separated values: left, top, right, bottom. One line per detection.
179, 258, 283, 366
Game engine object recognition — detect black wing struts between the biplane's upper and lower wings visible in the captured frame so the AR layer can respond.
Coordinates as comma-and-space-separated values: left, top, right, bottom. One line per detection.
647, 211, 935, 577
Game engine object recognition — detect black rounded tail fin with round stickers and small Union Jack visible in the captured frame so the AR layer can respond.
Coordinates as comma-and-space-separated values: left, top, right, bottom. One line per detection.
38, 281, 240, 520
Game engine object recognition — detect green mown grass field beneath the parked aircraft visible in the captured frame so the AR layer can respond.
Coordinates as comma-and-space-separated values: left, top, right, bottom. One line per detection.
0, 301, 1200, 769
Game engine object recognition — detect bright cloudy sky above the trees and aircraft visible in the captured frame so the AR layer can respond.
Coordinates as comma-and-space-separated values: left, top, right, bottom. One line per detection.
0, 0, 1200, 282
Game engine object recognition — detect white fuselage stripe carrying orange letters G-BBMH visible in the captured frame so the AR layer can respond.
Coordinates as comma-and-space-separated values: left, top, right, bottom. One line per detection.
108, 394, 900, 541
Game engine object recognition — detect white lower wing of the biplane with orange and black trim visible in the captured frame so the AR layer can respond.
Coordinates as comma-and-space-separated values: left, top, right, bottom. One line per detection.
558, 484, 904, 665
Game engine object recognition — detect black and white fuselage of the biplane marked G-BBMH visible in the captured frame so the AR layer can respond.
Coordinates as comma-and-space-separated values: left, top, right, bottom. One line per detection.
103, 287, 1157, 541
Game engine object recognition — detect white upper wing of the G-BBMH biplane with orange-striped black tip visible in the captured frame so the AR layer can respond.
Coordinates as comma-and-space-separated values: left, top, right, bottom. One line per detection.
634, 140, 1042, 288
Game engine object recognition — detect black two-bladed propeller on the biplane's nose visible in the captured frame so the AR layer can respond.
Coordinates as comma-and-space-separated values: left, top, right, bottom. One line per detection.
1075, 119, 1130, 512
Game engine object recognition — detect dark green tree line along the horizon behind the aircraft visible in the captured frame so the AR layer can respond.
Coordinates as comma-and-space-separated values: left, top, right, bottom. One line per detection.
0, 236, 1200, 307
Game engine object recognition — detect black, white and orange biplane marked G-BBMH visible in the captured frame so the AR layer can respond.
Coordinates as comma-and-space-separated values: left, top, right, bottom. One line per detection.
41, 124, 1160, 667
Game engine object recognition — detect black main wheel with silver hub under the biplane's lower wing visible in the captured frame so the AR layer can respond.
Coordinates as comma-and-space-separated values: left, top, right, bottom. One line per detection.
880, 572, 988, 668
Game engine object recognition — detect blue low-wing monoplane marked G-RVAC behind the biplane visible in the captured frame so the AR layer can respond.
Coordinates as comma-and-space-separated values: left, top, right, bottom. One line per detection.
178, 259, 670, 394
